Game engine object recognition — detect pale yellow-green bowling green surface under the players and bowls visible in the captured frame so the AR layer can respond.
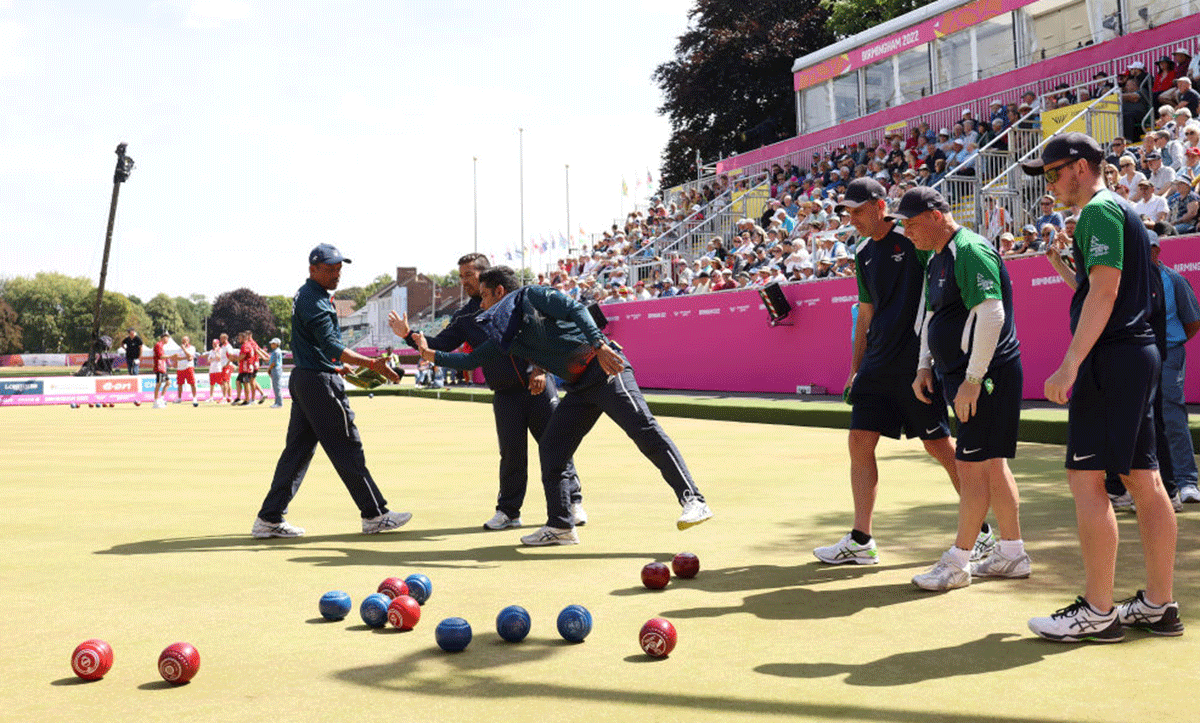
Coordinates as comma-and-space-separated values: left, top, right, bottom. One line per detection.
0, 395, 1200, 723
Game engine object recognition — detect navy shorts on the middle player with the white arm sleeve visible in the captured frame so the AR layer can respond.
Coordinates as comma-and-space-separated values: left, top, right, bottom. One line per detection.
942, 358, 1025, 462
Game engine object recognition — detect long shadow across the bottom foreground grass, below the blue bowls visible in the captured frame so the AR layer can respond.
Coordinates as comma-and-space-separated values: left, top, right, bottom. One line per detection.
332, 637, 1089, 723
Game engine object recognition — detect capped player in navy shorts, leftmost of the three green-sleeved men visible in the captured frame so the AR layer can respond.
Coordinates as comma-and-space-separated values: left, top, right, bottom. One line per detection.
812, 178, 964, 564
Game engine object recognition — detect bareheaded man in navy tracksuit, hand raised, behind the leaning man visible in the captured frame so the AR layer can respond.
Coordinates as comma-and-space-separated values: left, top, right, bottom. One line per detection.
389, 253, 587, 530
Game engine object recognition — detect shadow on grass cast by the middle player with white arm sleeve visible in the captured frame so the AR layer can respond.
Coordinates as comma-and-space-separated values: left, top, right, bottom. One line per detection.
661, 582, 929, 620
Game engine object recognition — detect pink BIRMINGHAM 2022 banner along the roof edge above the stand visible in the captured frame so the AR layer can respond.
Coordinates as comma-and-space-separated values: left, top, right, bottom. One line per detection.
792, 0, 1034, 90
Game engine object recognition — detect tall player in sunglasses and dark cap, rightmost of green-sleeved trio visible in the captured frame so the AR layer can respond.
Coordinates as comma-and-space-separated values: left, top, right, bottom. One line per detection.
1024, 132, 1183, 643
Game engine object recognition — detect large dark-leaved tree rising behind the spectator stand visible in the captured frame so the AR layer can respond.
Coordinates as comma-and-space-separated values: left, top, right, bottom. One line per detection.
652, 0, 833, 186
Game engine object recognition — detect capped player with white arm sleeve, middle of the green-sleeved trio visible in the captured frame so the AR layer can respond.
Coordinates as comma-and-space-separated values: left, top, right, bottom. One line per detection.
895, 182, 1030, 591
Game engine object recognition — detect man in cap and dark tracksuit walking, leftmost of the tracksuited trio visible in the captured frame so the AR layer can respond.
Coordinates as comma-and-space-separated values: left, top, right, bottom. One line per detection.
251, 244, 413, 537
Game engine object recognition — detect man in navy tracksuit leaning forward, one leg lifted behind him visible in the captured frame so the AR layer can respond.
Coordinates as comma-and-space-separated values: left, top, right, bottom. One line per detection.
414, 267, 713, 545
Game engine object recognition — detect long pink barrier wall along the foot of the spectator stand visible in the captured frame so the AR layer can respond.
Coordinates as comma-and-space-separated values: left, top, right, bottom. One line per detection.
604, 237, 1200, 404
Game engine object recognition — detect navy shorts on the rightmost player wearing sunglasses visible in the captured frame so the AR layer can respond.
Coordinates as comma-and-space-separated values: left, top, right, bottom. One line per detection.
1067, 345, 1162, 474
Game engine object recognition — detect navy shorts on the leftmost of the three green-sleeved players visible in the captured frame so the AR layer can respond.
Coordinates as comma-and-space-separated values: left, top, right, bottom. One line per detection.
850, 371, 950, 440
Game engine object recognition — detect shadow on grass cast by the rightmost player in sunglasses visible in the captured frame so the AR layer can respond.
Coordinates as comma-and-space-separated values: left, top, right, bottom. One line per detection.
755, 633, 1082, 687
